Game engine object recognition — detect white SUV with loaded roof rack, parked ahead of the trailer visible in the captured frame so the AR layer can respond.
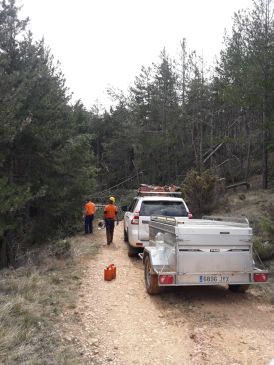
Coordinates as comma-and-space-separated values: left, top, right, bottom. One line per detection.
123, 190, 192, 257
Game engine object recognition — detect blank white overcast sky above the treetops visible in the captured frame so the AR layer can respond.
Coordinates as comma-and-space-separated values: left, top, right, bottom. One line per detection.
19, 0, 252, 108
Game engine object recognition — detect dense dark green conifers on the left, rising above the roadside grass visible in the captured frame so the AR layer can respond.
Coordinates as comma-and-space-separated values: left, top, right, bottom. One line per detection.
0, 0, 95, 266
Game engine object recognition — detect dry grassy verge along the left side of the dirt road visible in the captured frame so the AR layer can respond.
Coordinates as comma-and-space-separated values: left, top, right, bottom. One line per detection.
0, 237, 98, 365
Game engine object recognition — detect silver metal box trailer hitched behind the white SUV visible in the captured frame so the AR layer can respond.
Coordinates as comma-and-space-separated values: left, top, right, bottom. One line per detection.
141, 216, 268, 294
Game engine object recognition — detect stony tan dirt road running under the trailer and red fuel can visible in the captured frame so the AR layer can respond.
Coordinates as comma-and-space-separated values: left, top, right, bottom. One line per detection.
67, 224, 274, 365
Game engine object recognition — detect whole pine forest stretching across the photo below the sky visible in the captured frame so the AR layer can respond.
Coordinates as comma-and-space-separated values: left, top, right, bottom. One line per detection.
0, 0, 274, 266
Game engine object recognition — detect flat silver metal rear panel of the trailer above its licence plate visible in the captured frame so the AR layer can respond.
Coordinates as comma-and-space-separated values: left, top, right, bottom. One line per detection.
178, 226, 253, 274
